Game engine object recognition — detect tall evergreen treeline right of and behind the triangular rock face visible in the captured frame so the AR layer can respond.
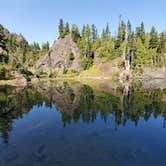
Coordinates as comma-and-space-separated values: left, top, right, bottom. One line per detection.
59, 19, 166, 69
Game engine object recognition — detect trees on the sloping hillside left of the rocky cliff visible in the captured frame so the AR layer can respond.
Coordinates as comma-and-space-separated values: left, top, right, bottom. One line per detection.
0, 25, 49, 79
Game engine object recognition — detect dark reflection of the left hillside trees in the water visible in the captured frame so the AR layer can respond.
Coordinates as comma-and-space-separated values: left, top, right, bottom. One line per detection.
0, 87, 47, 143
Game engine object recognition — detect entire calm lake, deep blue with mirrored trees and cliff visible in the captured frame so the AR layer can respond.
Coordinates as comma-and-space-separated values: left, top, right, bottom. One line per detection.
0, 82, 166, 166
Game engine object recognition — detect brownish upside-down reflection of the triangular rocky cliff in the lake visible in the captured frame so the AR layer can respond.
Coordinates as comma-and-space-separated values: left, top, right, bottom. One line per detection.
36, 83, 82, 114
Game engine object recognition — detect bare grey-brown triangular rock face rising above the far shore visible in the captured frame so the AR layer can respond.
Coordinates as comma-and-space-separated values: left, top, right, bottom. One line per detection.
35, 35, 81, 71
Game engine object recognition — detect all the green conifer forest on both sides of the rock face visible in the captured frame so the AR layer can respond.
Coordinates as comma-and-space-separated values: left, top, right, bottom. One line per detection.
0, 19, 166, 80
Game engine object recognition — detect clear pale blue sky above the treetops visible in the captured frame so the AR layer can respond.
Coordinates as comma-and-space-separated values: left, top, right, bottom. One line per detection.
0, 0, 166, 44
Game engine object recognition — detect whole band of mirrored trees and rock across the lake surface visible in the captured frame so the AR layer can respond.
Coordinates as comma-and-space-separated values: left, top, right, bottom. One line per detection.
0, 82, 166, 143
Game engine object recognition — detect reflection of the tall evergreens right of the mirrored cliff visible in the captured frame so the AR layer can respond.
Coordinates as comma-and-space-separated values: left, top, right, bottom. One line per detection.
59, 85, 166, 126
